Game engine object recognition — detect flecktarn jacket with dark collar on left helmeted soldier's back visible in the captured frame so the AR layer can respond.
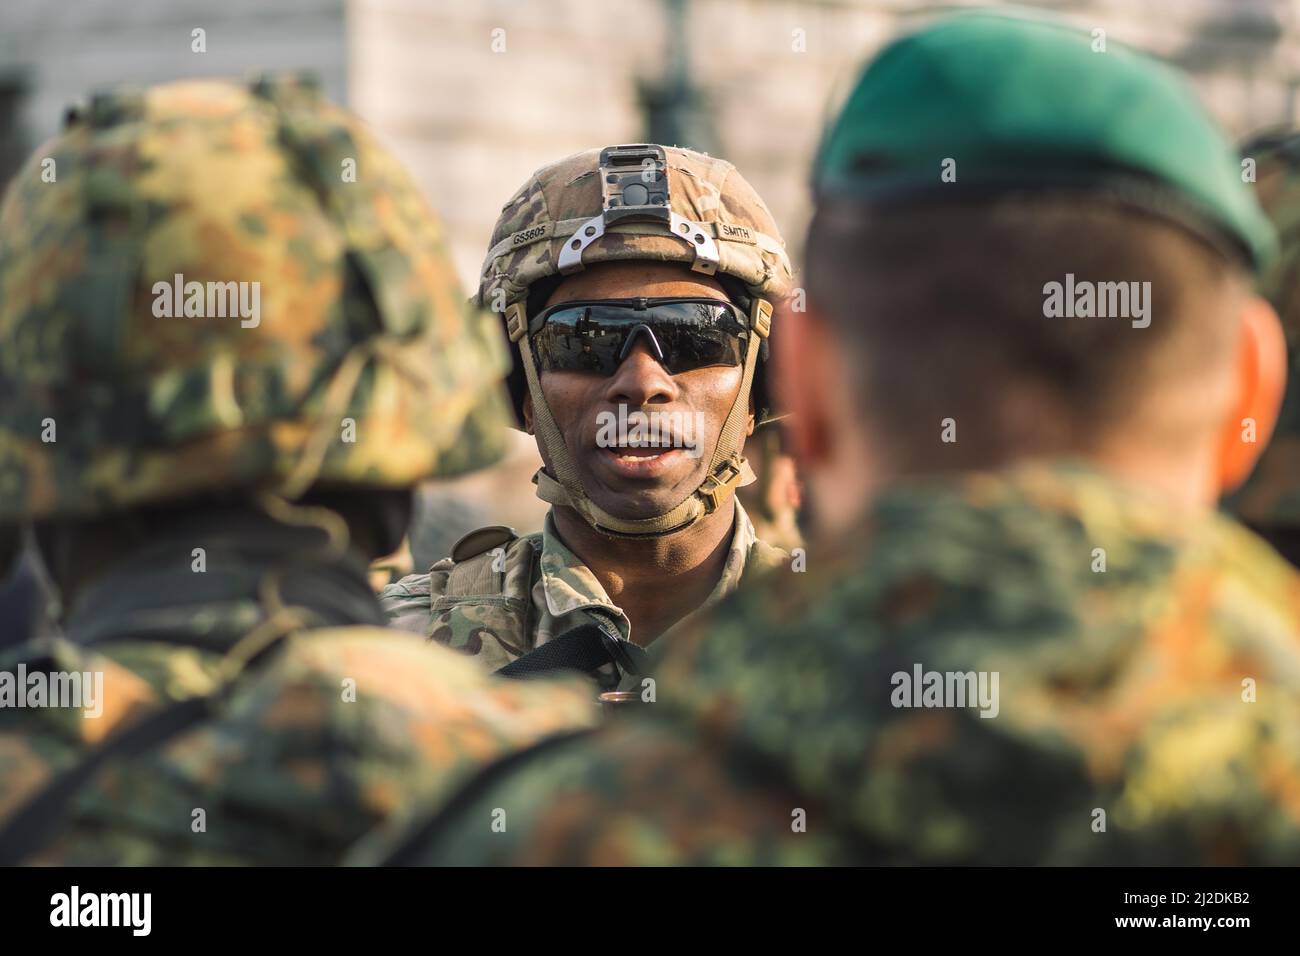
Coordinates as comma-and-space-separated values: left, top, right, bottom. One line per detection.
0, 528, 598, 865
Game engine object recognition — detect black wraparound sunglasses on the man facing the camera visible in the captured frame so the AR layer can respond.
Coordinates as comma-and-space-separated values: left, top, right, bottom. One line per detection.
528, 298, 750, 375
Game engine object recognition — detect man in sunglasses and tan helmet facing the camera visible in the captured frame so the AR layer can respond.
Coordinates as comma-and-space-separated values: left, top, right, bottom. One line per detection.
382, 144, 790, 689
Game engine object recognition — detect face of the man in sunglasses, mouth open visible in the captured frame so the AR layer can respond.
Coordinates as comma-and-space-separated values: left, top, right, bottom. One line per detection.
524, 263, 753, 518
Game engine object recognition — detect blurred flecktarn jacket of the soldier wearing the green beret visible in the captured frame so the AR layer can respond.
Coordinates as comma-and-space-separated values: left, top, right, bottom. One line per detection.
364, 466, 1300, 865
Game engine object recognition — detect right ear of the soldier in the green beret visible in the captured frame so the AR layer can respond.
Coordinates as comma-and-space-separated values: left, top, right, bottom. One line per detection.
1216, 295, 1287, 492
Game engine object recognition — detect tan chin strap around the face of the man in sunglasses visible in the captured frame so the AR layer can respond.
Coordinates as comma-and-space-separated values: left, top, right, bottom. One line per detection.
506, 298, 772, 538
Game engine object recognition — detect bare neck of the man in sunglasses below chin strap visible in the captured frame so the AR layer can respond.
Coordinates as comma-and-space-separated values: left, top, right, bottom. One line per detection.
554, 498, 736, 646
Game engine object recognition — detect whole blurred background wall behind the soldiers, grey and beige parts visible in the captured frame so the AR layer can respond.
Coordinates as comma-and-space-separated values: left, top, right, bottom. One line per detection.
0, 0, 1300, 538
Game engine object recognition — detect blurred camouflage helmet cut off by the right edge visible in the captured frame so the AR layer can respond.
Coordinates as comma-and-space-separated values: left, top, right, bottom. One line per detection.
1230, 133, 1300, 528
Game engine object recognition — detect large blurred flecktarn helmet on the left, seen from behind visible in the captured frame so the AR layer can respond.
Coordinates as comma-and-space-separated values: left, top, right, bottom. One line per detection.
0, 77, 508, 523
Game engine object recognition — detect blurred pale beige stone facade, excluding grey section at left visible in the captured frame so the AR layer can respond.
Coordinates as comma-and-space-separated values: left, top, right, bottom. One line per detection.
348, 0, 1300, 284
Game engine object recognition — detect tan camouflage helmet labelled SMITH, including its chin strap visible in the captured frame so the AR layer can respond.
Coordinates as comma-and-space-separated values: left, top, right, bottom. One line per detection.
478, 144, 792, 537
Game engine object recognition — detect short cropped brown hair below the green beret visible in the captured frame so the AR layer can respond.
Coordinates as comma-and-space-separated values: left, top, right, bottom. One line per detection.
805, 194, 1248, 467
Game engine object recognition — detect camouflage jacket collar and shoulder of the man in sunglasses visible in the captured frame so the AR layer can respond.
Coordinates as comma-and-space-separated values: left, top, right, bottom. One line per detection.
380, 501, 790, 691
